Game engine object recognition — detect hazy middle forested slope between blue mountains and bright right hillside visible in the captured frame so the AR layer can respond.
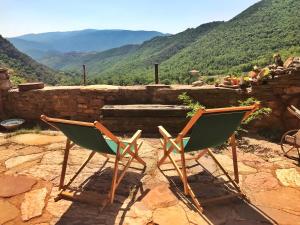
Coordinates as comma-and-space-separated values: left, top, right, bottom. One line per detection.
40, 22, 223, 85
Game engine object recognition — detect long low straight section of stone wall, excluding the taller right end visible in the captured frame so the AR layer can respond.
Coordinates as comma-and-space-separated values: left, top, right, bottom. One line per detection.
3, 85, 239, 121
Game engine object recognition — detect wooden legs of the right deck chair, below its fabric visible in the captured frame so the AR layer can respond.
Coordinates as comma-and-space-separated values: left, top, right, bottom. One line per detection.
158, 131, 245, 212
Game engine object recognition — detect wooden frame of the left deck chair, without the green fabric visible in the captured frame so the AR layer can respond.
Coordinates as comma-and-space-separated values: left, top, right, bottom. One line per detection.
41, 115, 146, 204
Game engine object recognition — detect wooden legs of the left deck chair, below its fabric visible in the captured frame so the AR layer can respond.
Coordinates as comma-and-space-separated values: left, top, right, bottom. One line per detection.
56, 134, 146, 206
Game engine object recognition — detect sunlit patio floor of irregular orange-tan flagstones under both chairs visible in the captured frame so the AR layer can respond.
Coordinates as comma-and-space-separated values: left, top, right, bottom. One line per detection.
0, 131, 300, 225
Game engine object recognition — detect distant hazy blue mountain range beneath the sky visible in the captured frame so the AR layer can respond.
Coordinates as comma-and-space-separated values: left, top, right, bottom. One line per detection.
8, 29, 165, 60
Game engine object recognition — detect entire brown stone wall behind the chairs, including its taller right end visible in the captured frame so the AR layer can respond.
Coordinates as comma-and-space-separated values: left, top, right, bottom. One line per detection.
2, 71, 300, 133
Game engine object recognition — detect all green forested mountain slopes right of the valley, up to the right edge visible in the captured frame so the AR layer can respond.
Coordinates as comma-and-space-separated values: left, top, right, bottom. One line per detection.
0, 0, 300, 85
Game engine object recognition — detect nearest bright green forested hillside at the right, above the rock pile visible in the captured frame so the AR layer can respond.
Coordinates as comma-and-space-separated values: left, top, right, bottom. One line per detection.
161, 0, 300, 81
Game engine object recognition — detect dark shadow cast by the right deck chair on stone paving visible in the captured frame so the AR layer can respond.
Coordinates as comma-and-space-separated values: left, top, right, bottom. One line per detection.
160, 156, 277, 225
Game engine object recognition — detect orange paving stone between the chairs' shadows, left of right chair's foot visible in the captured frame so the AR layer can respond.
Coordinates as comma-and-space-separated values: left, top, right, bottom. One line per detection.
142, 184, 178, 209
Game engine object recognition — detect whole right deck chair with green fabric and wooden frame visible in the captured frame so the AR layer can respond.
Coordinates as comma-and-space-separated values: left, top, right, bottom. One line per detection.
158, 104, 259, 212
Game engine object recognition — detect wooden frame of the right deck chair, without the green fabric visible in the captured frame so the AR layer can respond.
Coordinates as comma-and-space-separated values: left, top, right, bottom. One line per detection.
157, 103, 259, 212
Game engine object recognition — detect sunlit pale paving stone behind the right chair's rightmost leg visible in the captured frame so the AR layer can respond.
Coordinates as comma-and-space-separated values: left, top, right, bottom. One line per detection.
215, 154, 257, 174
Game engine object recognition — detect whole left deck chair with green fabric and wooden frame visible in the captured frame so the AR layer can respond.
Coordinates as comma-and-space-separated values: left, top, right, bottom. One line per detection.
41, 115, 146, 206
